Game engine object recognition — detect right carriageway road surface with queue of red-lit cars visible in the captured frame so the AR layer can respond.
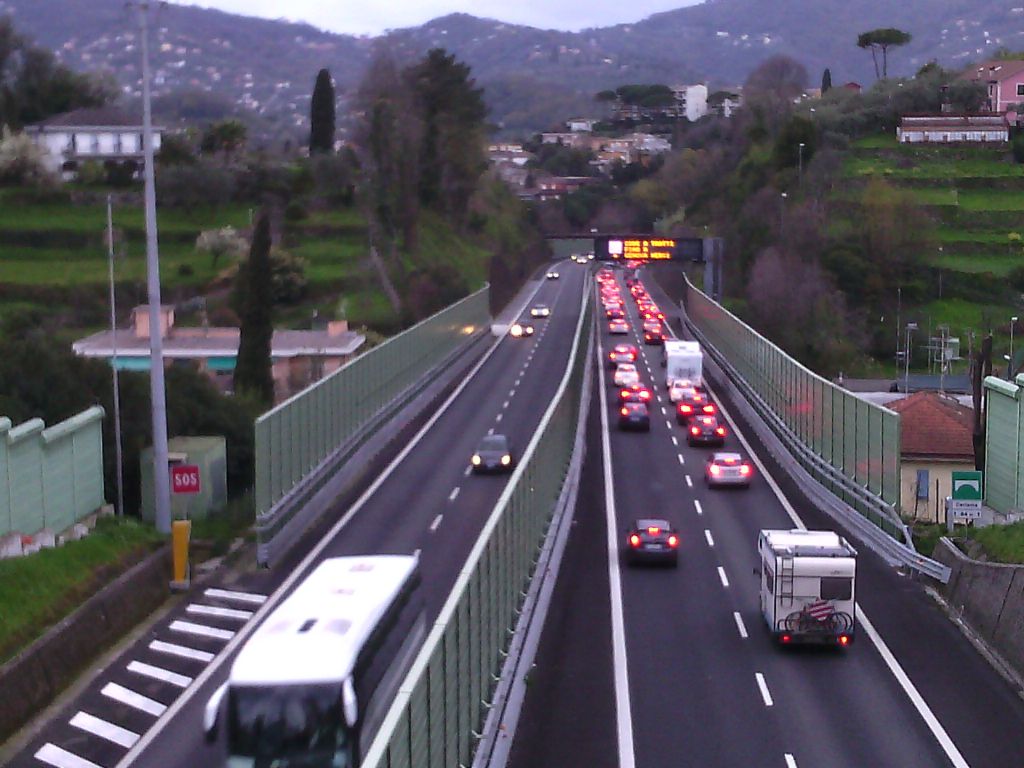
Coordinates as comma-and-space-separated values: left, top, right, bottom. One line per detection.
511, 268, 1024, 768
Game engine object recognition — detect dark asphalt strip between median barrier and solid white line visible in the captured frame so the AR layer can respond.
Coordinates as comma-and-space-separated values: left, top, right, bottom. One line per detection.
509, 408, 618, 768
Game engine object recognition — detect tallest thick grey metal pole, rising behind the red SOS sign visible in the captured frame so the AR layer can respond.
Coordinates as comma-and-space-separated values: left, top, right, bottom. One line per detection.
137, 2, 171, 534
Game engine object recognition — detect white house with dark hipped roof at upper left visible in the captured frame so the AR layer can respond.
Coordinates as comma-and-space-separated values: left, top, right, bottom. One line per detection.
25, 108, 164, 180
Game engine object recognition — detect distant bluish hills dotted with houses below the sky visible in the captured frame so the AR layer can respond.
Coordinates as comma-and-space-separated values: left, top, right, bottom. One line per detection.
0, 0, 1024, 140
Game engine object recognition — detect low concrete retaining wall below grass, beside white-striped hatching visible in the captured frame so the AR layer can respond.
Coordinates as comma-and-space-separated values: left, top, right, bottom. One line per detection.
0, 547, 171, 742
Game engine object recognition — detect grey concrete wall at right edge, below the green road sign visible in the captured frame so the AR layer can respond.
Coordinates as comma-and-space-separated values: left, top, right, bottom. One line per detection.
933, 539, 1024, 675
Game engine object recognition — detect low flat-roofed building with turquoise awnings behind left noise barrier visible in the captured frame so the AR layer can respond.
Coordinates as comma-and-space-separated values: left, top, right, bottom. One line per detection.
72, 305, 366, 402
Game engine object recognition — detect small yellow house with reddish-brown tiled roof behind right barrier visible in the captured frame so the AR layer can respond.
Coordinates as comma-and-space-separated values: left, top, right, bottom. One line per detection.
887, 391, 974, 522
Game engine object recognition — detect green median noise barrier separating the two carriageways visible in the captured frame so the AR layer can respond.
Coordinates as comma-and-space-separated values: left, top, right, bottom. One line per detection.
364, 274, 593, 768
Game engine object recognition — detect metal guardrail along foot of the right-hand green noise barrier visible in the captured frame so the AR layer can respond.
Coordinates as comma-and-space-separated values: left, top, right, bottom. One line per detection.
684, 281, 950, 584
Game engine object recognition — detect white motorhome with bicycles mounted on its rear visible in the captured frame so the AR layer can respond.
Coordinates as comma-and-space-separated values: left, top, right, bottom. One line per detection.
758, 529, 857, 647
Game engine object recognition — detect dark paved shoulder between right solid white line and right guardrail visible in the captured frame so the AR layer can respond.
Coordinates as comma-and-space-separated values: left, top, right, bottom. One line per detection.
650, 268, 1024, 767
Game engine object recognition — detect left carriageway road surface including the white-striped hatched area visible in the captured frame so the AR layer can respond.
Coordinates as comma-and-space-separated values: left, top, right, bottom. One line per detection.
9, 263, 586, 768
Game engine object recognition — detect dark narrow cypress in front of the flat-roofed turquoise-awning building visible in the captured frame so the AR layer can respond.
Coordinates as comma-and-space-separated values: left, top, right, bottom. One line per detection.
234, 211, 273, 407
